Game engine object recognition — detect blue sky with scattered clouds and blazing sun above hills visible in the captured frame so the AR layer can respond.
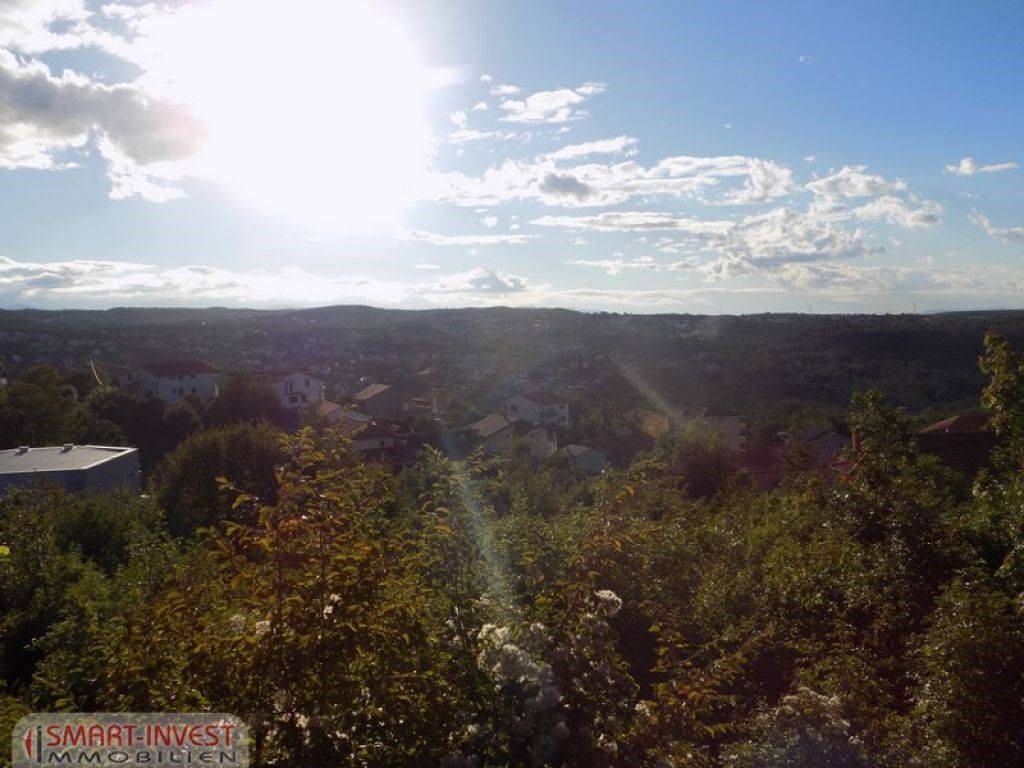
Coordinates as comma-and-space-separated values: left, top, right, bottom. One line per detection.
0, 0, 1024, 313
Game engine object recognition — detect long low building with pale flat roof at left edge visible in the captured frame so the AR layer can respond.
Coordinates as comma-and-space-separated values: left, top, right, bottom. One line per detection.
0, 443, 139, 493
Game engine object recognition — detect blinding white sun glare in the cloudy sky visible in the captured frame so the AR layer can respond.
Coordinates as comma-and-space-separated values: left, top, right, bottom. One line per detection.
138, 0, 429, 230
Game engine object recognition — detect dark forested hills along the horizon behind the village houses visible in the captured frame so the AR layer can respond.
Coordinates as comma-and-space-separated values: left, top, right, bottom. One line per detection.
0, 306, 1024, 412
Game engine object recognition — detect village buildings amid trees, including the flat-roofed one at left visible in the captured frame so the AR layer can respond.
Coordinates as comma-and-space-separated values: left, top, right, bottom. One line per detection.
0, 359, 995, 492
